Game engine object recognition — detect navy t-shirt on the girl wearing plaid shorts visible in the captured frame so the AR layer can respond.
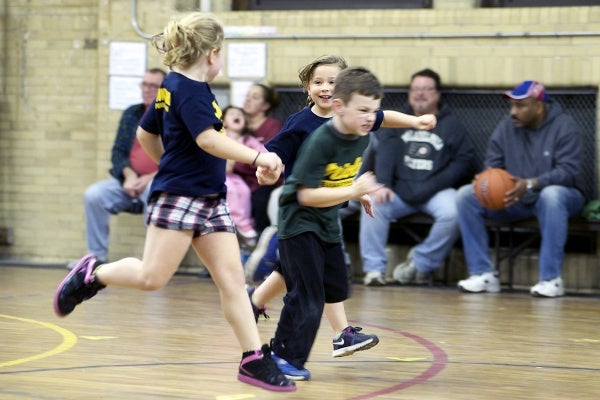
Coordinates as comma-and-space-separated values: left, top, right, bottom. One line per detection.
140, 72, 227, 197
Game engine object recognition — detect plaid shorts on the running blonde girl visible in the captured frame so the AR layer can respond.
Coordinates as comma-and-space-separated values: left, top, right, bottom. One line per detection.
147, 192, 236, 237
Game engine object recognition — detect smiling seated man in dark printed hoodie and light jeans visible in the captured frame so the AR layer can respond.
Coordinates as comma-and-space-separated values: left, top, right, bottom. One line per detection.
360, 69, 474, 286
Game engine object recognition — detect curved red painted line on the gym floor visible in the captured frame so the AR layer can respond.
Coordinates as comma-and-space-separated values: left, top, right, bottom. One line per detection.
347, 323, 448, 400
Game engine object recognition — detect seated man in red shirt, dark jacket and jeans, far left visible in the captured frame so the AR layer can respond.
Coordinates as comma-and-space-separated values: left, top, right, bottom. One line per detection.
76, 68, 166, 267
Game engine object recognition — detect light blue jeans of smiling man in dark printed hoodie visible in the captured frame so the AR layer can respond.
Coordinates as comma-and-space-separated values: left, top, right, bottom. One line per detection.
360, 188, 459, 273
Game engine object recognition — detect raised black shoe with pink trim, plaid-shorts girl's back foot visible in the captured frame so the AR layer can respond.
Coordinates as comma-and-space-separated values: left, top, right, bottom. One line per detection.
54, 254, 106, 317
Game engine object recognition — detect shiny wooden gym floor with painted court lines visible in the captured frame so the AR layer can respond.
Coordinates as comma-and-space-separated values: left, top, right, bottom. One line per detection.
0, 266, 600, 400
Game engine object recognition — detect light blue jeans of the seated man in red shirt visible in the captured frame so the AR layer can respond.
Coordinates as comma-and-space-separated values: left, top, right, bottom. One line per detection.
83, 177, 151, 261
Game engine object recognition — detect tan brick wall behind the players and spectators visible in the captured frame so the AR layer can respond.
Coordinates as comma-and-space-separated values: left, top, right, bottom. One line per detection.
0, 0, 600, 286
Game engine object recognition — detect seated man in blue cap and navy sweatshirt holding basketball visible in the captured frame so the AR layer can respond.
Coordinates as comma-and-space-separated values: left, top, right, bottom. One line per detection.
457, 81, 585, 297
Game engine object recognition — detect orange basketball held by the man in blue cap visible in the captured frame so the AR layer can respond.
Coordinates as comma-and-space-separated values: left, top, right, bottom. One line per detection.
473, 168, 515, 210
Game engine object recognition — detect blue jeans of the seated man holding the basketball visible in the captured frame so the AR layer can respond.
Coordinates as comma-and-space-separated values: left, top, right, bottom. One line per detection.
456, 185, 585, 281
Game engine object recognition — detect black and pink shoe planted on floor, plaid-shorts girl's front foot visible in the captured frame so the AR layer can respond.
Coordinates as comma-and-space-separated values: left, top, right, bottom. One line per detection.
238, 344, 296, 392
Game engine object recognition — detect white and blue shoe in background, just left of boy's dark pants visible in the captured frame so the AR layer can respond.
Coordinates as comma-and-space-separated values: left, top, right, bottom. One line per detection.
244, 225, 279, 282
